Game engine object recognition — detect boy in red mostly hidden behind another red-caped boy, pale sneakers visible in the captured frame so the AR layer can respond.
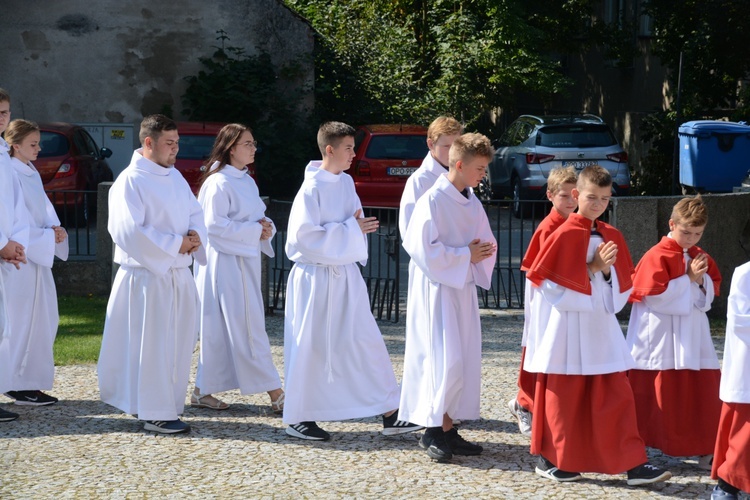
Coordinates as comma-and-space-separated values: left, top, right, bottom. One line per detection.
508, 167, 577, 436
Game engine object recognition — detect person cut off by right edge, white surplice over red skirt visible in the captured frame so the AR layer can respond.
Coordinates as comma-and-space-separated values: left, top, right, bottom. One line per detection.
711, 262, 750, 500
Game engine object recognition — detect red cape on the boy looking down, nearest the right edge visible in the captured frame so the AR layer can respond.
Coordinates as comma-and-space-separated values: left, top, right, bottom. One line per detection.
630, 236, 721, 302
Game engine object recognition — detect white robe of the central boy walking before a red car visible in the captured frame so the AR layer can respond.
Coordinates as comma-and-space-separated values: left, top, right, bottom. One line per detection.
284, 161, 399, 424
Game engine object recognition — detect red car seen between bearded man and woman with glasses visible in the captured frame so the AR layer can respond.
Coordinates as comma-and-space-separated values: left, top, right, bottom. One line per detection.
174, 122, 255, 195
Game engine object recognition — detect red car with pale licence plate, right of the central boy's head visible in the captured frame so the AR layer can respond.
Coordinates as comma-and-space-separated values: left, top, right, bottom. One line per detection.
347, 124, 428, 207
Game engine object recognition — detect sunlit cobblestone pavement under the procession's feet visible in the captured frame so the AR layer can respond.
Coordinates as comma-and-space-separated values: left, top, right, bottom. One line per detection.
0, 311, 724, 499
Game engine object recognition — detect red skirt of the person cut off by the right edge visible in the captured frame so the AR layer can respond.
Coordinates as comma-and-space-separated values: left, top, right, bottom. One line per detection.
711, 402, 750, 492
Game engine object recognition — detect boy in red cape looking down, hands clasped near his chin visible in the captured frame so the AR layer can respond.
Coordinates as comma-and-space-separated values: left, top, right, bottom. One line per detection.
627, 197, 721, 469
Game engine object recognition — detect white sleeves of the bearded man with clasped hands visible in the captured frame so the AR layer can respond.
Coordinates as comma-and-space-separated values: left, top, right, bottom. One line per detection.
107, 179, 188, 276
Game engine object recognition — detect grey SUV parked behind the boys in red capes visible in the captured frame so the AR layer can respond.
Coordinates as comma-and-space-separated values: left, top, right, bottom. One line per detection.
483, 114, 630, 217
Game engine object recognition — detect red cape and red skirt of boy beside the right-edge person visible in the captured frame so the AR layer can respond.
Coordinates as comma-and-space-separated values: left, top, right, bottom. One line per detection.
628, 236, 721, 457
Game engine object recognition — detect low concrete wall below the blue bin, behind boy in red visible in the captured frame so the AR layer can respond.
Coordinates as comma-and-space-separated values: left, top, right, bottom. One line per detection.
612, 193, 750, 318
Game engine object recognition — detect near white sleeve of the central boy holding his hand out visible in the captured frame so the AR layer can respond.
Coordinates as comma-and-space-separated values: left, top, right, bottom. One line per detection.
287, 191, 367, 265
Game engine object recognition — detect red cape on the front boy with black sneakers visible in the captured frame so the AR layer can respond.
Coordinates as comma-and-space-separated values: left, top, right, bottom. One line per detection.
526, 214, 633, 295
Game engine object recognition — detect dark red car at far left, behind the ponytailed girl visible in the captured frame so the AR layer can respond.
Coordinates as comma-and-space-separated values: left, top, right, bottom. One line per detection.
34, 122, 113, 226
